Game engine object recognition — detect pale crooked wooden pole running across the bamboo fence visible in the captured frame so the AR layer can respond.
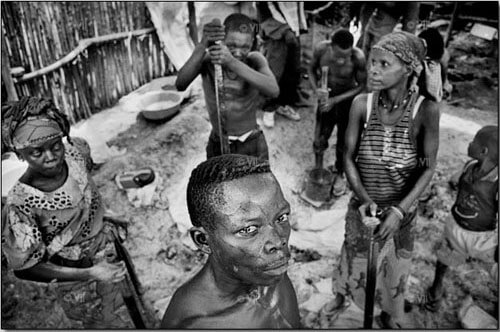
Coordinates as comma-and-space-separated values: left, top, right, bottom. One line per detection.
15, 28, 155, 83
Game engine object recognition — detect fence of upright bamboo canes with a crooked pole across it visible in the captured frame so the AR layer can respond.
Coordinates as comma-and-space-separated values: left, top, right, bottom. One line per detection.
1, 1, 174, 123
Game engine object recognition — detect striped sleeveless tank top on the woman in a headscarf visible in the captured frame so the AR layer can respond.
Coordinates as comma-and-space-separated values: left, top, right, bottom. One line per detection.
356, 92, 424, 208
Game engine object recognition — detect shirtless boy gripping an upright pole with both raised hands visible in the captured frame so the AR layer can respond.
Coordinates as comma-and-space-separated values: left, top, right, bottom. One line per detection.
175, 14, 279, 160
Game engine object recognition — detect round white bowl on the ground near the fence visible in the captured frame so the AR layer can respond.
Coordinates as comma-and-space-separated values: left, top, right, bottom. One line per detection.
139, 90, 183, 120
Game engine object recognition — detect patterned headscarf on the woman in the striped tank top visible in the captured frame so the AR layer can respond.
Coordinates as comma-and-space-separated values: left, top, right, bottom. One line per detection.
372, 31, 426, 76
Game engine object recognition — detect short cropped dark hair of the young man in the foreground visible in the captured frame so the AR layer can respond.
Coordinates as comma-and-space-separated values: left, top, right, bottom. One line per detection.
187, 154, 271, 230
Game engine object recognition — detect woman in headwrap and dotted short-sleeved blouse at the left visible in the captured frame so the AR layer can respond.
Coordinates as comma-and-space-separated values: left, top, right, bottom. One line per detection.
2, 97, 150, 329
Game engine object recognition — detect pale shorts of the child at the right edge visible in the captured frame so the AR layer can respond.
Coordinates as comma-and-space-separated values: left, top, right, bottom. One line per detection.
437, 214, 498, 266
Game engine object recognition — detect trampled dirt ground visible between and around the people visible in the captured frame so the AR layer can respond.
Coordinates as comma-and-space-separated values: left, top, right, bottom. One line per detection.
1, 29, 498, 329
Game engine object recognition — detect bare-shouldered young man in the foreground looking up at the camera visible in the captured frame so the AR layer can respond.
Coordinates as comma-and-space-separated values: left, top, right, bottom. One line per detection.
161, 154, 300, 329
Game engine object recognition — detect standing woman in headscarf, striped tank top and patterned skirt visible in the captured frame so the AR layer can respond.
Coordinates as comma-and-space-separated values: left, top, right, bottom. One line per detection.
327, 32, 439, 328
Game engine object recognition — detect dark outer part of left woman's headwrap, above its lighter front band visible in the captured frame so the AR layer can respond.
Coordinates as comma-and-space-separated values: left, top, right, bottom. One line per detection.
2, 97, 71, 151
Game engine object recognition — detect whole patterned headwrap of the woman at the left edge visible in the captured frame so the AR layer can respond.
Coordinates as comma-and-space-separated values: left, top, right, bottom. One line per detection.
2, 97, 70, 151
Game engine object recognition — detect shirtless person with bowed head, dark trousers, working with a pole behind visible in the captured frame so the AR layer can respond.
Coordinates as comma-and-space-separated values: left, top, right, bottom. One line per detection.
312, 29, 366, 196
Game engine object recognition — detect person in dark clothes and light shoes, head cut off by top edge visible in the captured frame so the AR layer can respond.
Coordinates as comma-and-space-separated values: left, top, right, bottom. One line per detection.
258, 2, 300, 128
